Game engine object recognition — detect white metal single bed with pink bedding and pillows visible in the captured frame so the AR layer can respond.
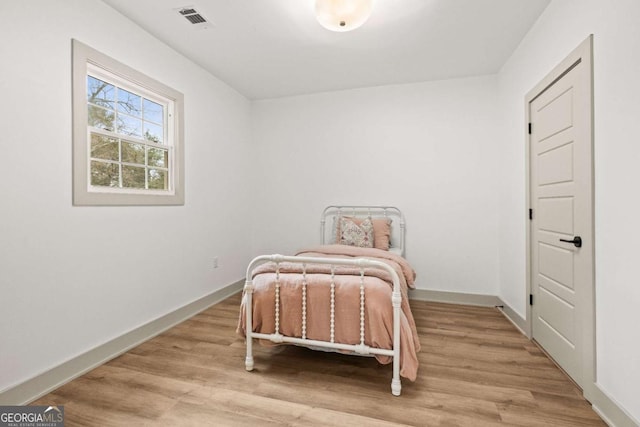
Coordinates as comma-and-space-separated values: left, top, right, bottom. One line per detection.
238, 206, 420, 396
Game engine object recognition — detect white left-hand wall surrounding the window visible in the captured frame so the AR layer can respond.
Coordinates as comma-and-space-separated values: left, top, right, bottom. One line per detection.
0, 0, 253, 390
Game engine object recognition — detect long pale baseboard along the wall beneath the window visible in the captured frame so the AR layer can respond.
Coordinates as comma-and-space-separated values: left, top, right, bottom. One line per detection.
0, 279, 244, 405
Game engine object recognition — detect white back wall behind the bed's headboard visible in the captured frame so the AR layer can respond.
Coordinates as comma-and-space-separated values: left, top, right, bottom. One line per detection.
252, 76, 498, 295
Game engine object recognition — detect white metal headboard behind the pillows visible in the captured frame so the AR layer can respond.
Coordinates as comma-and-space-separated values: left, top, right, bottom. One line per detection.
320, 206, 405, 256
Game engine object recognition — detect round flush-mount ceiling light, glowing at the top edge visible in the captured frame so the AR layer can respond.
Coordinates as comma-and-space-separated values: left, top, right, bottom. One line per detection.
316, 0, 373, 32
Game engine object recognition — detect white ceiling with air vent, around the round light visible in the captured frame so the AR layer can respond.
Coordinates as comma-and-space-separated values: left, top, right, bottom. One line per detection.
103, 0, 550, 99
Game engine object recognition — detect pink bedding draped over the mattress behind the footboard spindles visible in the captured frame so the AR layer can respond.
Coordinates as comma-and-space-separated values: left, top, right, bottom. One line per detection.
237, 245, 420, 381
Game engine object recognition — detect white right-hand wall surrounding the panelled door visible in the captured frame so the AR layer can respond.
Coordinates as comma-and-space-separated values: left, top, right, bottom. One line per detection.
499, 0, 640, 420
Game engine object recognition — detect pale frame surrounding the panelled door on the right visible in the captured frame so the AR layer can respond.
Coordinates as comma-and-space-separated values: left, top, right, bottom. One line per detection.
524, 34, 596, 401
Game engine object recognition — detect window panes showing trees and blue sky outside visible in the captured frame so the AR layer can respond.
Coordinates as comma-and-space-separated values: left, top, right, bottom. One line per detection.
87, 75, 169, 190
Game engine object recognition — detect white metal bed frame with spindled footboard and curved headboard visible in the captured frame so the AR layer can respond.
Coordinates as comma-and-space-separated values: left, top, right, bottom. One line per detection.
244, 206, 405, 396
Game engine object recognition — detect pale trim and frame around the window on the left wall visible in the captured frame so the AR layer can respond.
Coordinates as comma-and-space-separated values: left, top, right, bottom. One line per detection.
72, 40, 184, 206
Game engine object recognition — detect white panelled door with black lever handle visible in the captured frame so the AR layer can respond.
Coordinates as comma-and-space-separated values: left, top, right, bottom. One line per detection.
528, 38, 593, 386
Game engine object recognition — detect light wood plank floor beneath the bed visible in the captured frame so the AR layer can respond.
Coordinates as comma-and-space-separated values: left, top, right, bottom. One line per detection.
33, 295, 605, 427
